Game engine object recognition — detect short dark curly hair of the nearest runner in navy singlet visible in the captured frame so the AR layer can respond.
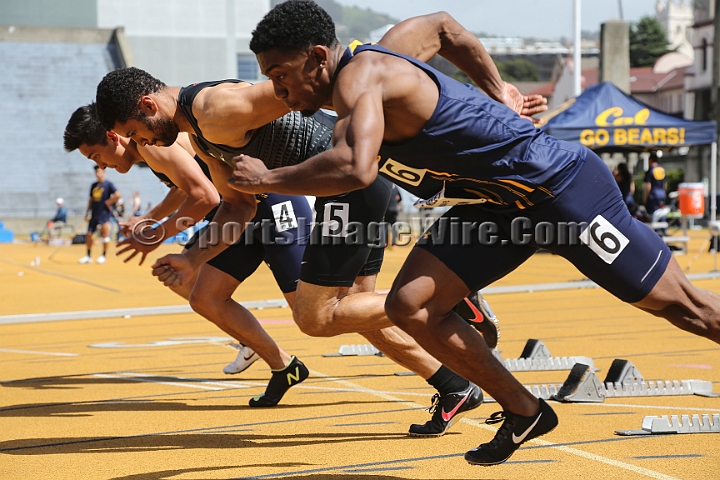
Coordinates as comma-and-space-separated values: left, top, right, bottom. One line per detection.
250, 0, 340, 54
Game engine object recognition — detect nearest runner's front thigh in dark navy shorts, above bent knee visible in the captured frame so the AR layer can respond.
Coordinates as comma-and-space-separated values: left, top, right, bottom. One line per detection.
414, 206, 537, 291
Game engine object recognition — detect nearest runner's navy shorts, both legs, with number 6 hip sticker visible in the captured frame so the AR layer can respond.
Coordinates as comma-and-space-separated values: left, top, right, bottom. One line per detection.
416, 151, 672, 303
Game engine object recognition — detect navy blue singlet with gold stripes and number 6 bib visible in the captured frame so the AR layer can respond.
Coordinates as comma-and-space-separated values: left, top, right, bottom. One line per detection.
338, 45, 586, 211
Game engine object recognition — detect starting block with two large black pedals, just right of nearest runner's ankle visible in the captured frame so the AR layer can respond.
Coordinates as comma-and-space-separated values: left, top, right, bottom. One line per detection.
485, 359, 720, 403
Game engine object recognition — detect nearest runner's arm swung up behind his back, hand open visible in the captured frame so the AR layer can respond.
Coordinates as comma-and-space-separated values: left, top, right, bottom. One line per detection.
378, 12, 547, 121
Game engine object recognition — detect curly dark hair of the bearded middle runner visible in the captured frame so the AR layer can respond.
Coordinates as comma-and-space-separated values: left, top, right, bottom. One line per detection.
96, 67, 166, 130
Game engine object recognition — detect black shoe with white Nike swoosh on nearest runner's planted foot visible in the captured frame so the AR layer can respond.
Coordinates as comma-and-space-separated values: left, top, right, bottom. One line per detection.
465, 398, 558, 466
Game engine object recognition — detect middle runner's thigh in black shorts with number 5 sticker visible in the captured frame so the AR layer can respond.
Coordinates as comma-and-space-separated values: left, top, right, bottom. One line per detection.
300, 177, 390, 287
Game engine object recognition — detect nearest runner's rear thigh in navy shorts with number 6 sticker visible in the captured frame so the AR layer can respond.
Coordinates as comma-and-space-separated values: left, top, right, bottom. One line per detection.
530, 152, 672, 303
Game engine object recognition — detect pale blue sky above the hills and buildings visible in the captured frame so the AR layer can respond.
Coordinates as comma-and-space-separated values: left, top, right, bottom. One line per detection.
336, 0, 660, 39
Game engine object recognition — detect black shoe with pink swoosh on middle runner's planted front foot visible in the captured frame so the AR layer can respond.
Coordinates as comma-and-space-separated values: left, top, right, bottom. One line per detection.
408, 382, 482, 437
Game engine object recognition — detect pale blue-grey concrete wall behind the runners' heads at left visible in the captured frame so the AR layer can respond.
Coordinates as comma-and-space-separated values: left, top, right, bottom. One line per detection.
0, 26, 167, 221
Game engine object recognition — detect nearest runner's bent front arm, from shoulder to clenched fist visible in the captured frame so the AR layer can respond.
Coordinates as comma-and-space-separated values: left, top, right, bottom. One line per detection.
232, 65, 385, 196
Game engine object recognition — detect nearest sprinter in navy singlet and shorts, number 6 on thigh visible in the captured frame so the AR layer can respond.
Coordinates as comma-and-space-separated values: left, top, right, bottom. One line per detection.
248, 0, 720, 465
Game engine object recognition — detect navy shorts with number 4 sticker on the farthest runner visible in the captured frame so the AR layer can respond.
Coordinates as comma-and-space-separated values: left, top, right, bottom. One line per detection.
185, 193, 312, 293
